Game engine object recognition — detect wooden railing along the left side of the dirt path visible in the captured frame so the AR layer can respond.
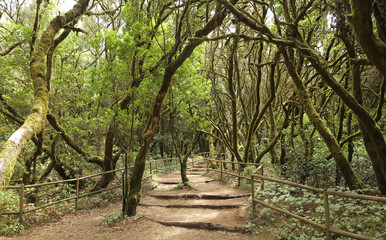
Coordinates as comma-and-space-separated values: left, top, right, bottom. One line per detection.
0, 158, 202, 224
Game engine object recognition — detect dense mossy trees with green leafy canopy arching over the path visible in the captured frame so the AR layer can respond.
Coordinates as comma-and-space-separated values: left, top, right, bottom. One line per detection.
0, 0, 386, 215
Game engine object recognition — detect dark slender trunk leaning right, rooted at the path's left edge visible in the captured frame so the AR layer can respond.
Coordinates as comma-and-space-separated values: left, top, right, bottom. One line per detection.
122, 3, 234, 216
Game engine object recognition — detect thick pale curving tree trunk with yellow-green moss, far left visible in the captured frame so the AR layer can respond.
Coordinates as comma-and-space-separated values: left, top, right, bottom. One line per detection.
0, 0, 89, 189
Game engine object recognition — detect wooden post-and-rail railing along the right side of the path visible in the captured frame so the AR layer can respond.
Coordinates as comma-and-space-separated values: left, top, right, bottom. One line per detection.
206, 159, 386, 240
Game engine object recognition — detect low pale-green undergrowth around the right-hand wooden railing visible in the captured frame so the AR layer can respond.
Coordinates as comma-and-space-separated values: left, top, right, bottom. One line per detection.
207, 166, 386, 240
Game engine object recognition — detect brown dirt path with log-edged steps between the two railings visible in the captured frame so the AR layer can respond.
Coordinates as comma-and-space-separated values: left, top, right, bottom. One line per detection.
0, 166, 275, 240
